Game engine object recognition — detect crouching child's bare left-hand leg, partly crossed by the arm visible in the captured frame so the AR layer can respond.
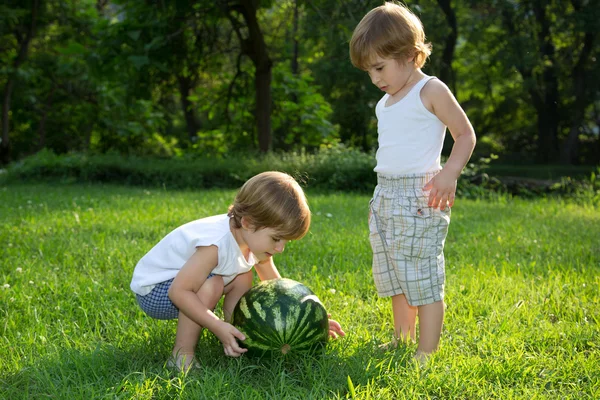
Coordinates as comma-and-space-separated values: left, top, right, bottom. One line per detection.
173, 275, 223, 371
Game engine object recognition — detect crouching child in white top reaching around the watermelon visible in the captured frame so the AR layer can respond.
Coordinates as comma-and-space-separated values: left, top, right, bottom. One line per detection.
130, 171, 345, 372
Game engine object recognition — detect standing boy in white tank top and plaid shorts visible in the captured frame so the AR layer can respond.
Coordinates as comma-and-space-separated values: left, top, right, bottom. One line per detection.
350, 2, 475, 361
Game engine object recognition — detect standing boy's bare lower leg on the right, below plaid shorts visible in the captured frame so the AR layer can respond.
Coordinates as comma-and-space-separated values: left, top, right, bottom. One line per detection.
415, 301, 444, 361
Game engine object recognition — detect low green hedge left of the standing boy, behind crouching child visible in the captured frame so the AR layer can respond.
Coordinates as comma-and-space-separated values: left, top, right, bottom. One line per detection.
3, 146, 376, 191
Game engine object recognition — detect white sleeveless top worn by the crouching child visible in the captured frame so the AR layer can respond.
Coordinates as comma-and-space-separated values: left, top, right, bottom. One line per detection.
130, 214, 256, 296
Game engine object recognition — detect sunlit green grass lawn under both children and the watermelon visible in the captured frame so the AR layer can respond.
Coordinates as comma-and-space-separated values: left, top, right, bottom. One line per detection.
0, 184, 600, 400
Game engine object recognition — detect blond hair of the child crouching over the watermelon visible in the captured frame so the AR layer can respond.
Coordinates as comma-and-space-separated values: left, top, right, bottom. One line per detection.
227, 171, 310, 240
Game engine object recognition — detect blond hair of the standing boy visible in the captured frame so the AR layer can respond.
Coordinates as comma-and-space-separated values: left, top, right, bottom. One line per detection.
350, 2, 431, 70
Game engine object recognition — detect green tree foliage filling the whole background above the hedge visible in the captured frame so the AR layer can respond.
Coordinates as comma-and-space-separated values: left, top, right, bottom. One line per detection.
0, 0, 600, 165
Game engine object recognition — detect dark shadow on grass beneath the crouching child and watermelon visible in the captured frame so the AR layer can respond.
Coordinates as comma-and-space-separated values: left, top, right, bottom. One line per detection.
0, 337, 405, 400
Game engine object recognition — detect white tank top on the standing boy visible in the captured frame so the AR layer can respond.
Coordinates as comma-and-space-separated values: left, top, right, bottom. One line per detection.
374, 75, 446, 175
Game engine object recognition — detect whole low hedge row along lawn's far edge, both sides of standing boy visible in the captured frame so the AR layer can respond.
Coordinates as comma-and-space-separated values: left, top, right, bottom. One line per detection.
0, 145, 600, 204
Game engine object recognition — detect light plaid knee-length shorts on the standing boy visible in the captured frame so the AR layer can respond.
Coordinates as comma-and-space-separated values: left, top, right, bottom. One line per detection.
369, 173, 450, 306
